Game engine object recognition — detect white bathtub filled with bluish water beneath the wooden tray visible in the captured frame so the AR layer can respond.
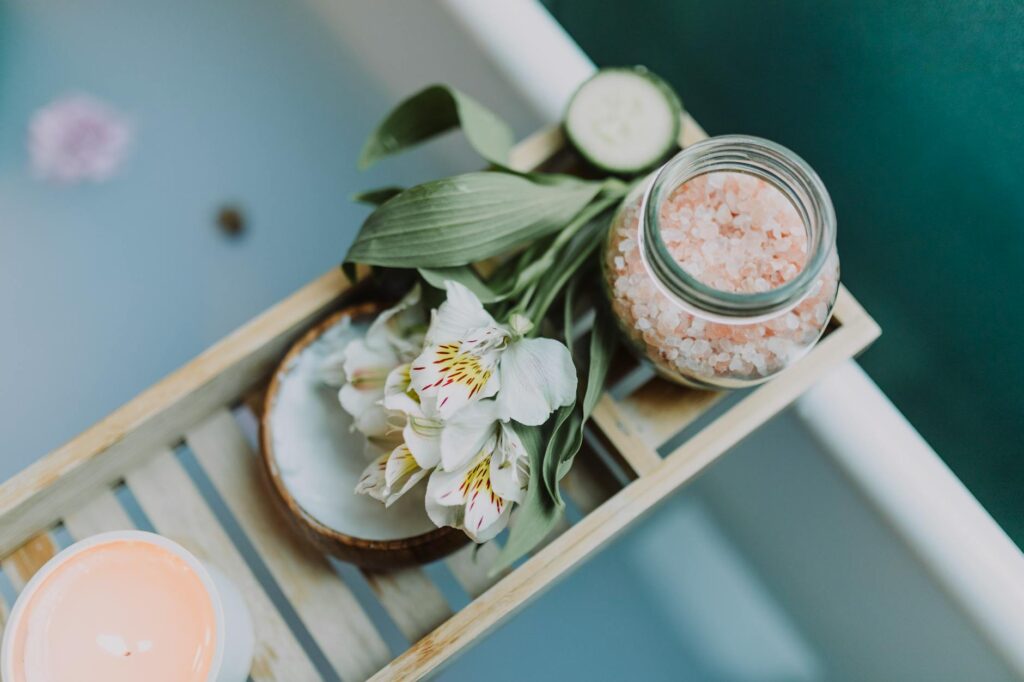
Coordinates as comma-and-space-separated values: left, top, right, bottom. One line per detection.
0, 0, 1024, 681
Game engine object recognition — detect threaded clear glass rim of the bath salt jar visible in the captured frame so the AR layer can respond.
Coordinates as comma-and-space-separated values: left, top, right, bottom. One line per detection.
638, 135, 836, 322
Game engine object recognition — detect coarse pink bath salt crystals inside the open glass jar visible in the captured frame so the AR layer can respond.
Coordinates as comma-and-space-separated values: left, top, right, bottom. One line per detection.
604, 172, 839, 385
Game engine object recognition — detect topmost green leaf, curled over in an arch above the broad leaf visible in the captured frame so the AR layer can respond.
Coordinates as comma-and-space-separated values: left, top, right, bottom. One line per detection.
359, 85, 515, 168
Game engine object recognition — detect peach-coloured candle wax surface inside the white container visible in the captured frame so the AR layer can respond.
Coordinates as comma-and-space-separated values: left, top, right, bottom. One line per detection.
5, 538, 217, 682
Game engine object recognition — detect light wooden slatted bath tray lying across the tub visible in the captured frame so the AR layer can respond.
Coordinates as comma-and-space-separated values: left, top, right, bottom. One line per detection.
0, 118, 879, 682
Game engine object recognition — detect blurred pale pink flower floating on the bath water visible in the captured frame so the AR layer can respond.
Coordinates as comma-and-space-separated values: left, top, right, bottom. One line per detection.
29, 94, 132, 183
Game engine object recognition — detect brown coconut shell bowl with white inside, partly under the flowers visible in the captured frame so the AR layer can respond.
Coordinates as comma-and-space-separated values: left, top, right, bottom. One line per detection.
260, 302, 467, 569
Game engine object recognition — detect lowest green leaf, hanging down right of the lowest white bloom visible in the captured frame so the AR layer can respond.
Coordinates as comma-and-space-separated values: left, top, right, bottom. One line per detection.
489, 422, 564, 576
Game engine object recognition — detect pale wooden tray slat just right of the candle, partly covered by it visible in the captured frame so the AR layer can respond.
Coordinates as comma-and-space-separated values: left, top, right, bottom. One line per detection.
128, 450, 319, 682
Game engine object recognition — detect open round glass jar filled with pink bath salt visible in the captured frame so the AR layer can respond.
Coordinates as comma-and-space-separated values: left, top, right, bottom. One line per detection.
602, 135, 839, 389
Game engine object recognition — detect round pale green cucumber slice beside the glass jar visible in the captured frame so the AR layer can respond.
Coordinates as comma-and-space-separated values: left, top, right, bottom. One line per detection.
565, 67, 683, 174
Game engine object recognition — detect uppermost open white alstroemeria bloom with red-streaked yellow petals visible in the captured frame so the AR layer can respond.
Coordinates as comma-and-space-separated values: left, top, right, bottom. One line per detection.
410, 281, 577, 426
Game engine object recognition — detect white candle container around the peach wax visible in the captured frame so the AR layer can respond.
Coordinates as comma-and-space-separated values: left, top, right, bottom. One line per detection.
0, 530, 255, 682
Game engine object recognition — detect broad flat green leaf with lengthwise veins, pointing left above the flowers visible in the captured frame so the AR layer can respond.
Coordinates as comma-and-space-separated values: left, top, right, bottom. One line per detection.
345, 172, 601, 268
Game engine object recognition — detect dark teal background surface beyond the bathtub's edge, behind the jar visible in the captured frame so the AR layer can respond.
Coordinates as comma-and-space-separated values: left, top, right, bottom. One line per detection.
547, 0, 1024, 545
